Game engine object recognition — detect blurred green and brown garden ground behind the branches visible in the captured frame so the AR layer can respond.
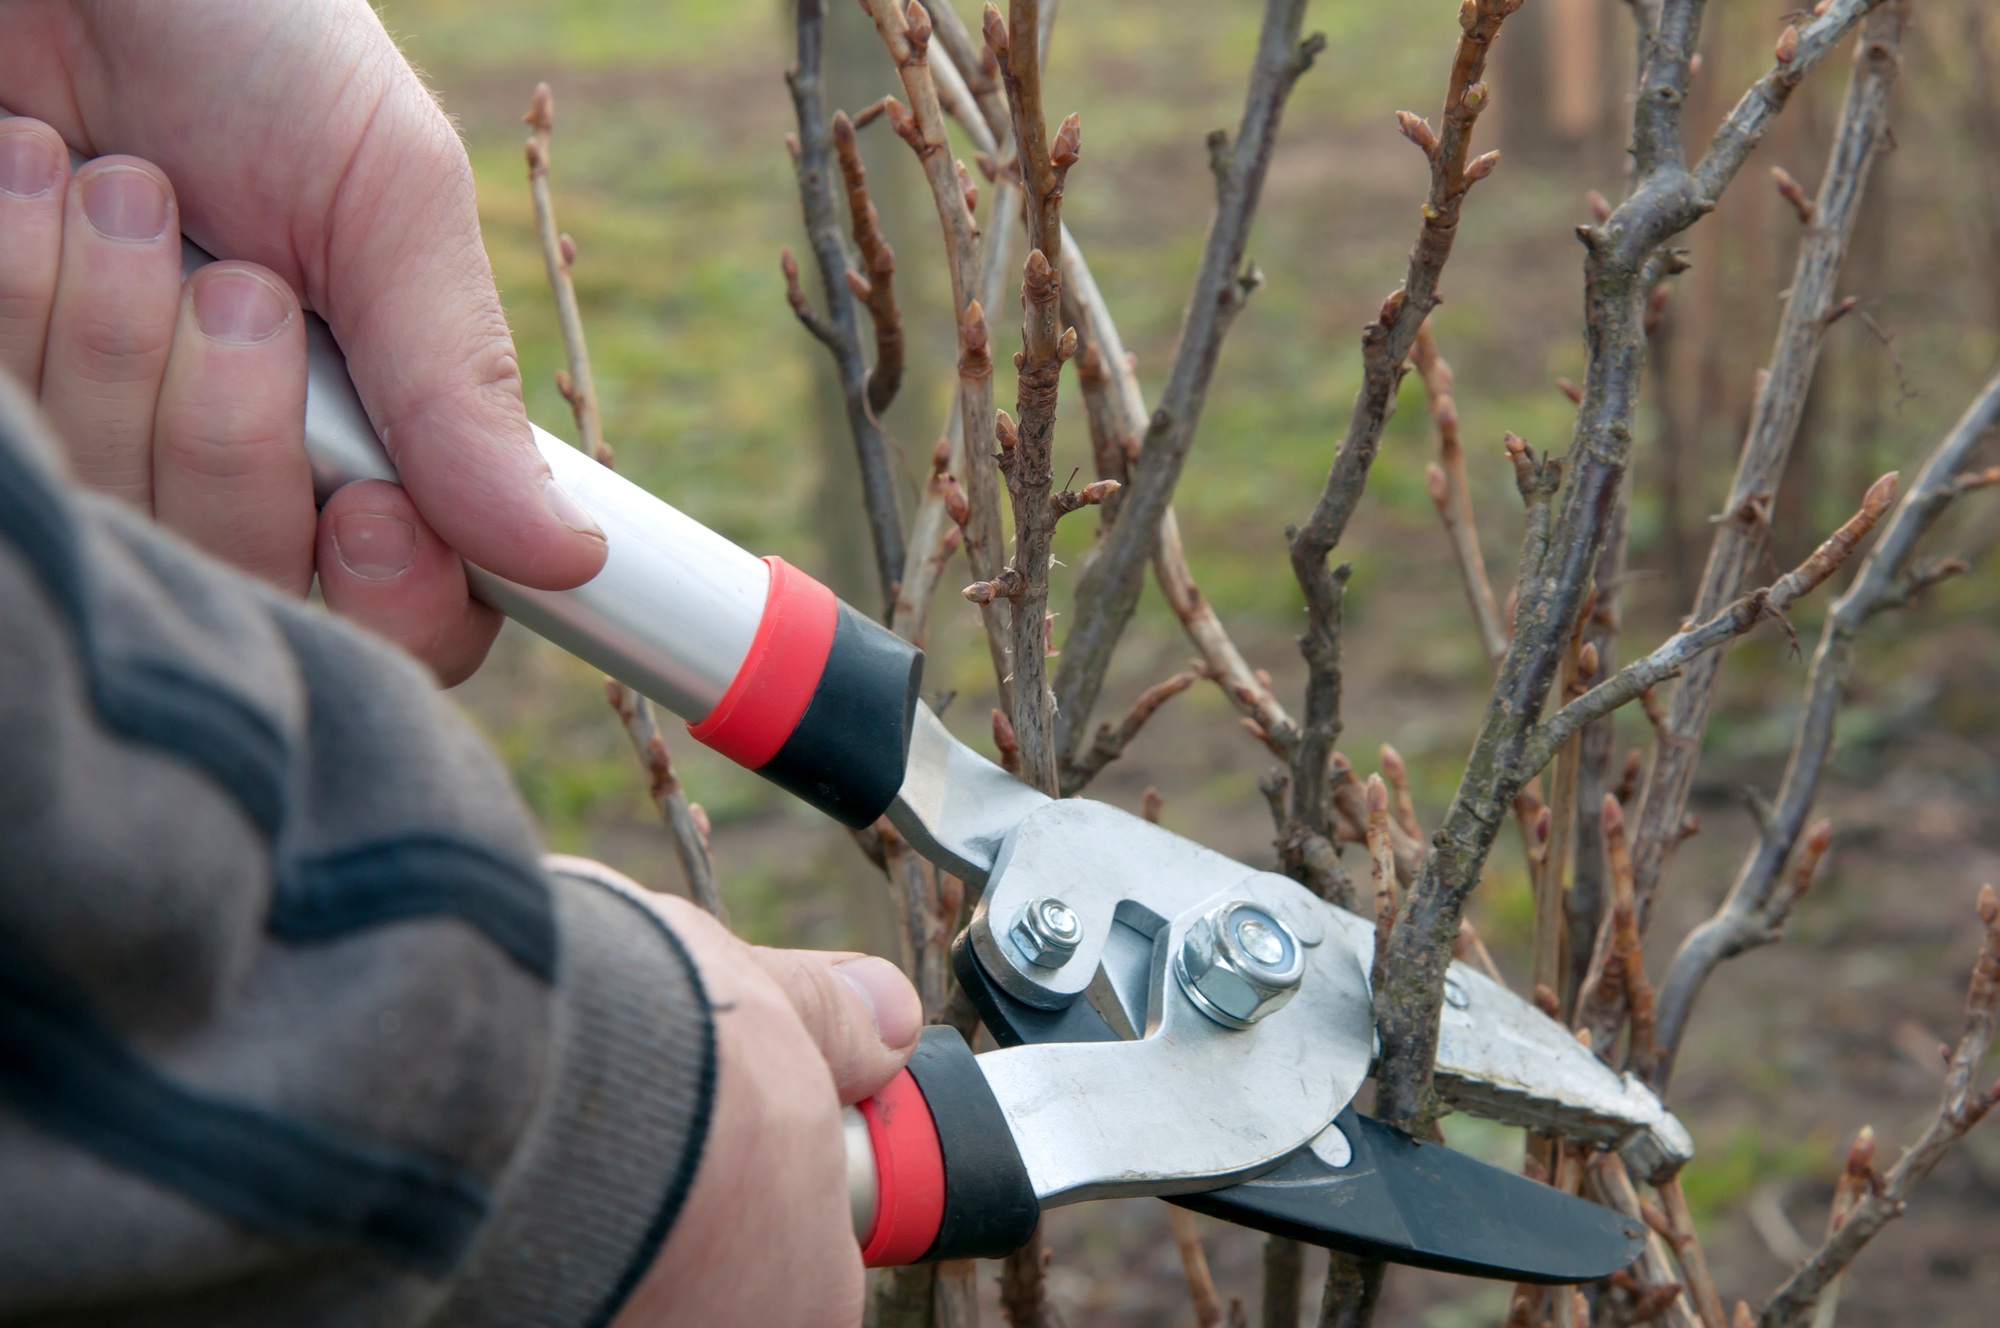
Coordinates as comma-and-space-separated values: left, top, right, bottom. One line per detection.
380, 0, 2000, 1328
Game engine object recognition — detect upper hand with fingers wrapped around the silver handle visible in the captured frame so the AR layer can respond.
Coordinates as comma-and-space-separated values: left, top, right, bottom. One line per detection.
0, 0, 604, 682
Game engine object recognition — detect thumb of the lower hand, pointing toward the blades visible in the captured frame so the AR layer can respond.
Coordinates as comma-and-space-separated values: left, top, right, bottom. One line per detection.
754, 946, 924, 1104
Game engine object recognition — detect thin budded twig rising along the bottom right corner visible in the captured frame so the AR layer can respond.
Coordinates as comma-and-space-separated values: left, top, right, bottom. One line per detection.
1758, 886, 2000, 1328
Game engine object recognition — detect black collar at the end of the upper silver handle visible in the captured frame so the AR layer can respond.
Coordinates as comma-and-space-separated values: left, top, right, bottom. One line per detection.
758, 604, 924, 830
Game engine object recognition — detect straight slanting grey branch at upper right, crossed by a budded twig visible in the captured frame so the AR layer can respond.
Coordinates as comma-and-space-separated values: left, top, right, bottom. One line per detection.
1632, 4, 1908, 924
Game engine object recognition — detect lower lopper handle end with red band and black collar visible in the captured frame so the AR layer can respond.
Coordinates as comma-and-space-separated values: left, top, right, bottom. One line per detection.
846, 1024, 1042, 1268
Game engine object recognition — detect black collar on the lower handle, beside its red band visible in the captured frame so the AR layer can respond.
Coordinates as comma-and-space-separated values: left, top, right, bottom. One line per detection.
910, 1024, 1042, 1264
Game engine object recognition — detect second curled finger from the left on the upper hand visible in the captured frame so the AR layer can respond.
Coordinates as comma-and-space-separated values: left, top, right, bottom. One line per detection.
42, 156, 180, 512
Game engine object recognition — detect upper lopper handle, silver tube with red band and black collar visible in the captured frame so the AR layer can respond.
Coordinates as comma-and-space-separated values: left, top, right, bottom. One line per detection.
203, 233, 924, 828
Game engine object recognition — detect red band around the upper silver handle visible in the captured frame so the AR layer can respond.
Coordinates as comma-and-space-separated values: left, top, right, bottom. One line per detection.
688, 558, 840, 770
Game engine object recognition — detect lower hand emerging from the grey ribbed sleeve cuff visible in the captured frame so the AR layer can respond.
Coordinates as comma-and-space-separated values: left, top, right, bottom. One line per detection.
612, 896, 922, 1328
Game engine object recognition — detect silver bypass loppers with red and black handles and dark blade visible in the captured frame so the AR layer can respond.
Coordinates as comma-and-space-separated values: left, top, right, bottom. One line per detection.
186, 231, 1694, 1282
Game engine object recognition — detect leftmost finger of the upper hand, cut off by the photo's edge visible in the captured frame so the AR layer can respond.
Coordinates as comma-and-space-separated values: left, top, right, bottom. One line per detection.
0, 116, 70, 392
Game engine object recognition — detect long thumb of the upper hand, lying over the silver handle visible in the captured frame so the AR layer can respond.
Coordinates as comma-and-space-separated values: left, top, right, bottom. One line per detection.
322, 74, 604, 590
